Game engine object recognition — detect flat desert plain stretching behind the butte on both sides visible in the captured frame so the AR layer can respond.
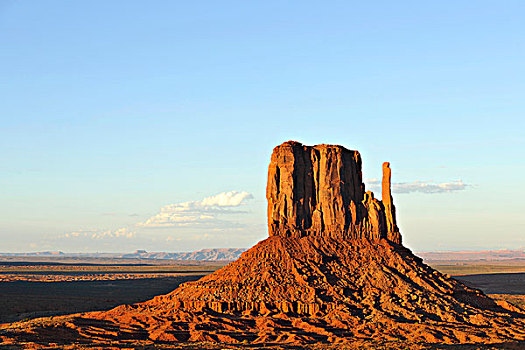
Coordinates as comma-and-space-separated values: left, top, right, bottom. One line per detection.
0, 257, 525, 349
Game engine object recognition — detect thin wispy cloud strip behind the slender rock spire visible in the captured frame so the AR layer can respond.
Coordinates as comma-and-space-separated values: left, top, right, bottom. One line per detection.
365, 179, 470, 194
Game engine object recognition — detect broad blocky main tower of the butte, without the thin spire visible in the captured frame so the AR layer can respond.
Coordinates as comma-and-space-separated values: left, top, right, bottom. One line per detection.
266, 141, 364, 237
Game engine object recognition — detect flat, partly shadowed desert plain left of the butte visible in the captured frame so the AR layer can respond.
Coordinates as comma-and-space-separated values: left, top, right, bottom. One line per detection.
0, 258, 223, 323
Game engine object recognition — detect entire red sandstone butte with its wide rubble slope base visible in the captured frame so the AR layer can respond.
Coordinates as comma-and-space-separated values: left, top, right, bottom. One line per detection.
1, 141, 525, 348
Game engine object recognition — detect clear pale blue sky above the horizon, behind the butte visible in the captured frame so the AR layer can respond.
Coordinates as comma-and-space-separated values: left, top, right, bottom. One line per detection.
0, 0, 525, 252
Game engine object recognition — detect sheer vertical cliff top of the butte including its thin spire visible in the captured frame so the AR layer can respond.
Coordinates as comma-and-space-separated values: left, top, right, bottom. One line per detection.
266, 141, 401, 243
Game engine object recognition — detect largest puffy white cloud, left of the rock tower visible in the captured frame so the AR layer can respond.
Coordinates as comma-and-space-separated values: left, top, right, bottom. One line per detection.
137, 191, 253, 228
